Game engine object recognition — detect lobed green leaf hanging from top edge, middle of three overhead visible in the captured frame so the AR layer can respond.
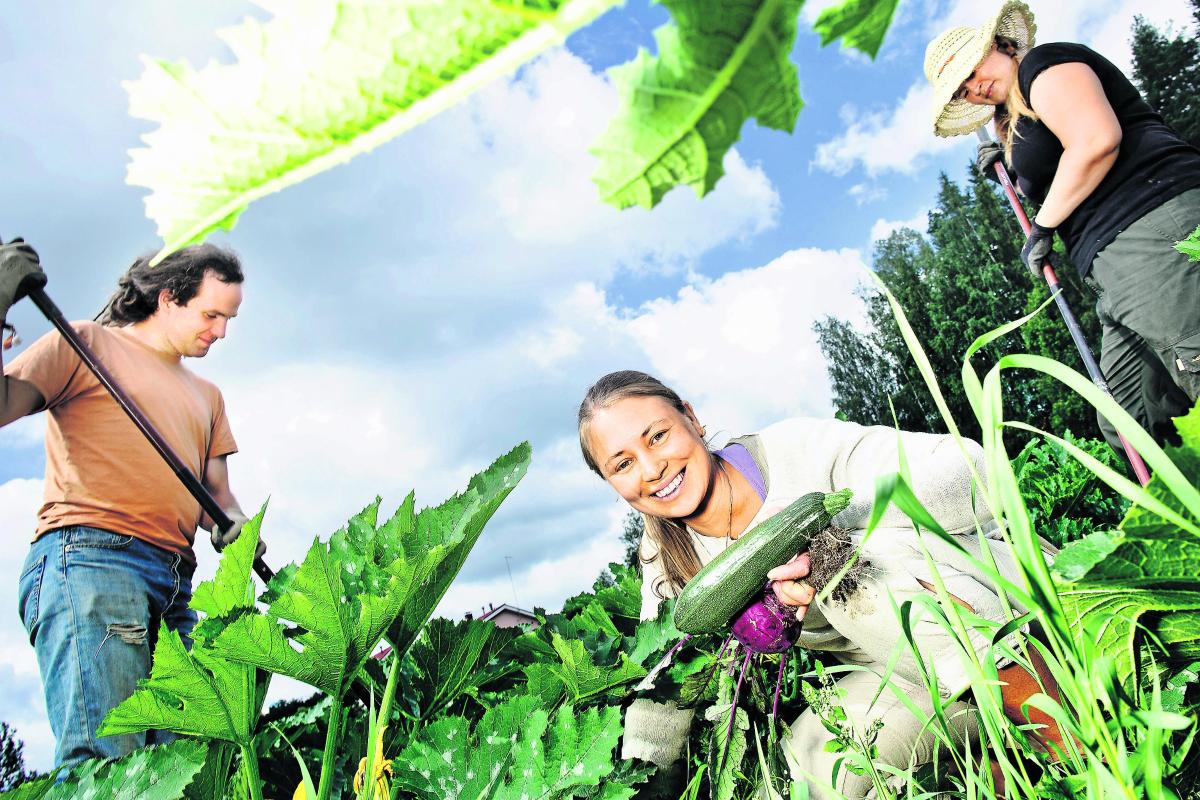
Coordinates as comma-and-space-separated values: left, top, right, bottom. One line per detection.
592, 0, 803, 209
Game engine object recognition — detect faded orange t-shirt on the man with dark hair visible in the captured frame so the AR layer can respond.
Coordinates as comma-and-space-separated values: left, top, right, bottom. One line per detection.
5, 321, 238, 564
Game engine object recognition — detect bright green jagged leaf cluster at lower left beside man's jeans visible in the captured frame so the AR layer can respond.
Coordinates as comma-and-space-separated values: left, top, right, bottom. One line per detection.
5, 444, 529, 800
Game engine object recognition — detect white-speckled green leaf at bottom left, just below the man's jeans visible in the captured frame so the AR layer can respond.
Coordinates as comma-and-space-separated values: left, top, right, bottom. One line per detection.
42, 739, 208, 800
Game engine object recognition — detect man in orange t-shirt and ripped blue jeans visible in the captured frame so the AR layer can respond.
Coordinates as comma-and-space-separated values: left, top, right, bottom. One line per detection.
0, 241, 245, 768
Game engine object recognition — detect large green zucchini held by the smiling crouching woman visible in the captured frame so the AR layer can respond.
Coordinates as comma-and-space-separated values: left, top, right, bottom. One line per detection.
674, 489, 851, 633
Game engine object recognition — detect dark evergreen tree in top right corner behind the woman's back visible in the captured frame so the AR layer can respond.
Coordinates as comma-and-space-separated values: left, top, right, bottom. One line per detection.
1133, 0, 1200, 146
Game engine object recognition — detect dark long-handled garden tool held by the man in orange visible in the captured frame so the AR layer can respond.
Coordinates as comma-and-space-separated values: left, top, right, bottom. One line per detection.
17, 268, 275, 583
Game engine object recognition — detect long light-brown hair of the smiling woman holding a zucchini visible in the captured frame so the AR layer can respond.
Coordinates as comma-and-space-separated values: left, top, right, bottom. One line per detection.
578, 369, 715, 599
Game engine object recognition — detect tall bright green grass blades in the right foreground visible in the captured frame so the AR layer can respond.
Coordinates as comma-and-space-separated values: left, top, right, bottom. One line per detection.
782, 284, 1200, 800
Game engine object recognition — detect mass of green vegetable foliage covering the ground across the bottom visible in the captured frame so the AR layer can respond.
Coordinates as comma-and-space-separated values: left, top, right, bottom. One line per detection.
2, 407, 1200, 800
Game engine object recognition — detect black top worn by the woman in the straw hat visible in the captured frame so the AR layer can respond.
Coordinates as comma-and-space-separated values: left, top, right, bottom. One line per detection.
1013, 42, 1200, 275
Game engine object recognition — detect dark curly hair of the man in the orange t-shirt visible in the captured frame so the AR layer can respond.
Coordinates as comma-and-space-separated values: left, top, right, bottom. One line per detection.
96, 245, 246, 326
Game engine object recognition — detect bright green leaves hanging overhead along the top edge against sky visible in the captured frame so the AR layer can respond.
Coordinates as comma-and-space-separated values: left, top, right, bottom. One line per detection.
126, 0, 896, 258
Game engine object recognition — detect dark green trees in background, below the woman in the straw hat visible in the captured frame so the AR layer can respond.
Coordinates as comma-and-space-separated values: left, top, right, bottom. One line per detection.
816, 168, 1099, 437
